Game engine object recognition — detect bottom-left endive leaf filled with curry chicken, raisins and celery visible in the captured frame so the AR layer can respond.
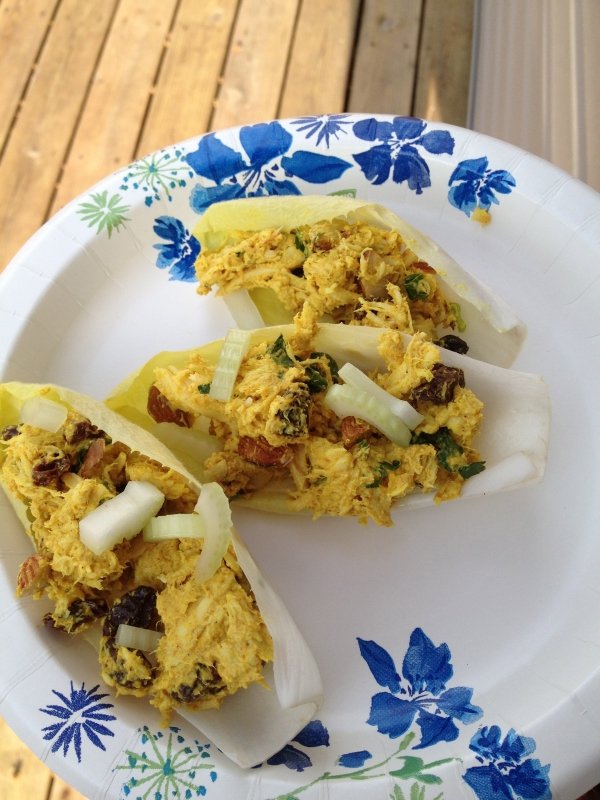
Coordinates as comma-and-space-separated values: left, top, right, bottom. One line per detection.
0, 383, 321, 766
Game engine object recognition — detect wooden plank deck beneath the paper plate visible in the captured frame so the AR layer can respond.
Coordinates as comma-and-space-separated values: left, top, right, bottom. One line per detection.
0, 0, 600, 800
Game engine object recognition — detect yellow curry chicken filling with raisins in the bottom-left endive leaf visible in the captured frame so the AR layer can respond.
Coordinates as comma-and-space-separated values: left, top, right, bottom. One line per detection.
0, 410, 273, 720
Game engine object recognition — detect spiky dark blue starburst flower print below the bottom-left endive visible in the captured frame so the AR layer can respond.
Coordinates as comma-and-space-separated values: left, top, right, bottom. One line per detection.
40, 681, 116, 761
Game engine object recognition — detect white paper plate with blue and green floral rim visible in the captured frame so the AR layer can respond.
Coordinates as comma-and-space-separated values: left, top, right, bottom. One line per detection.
0, 115, 600, 800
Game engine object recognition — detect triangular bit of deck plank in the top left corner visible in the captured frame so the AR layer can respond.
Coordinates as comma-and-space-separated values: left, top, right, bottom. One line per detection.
0, 0, 56, 149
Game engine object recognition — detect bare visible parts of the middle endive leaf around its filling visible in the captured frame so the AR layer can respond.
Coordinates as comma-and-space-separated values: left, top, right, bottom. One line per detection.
107, 323, 550, 513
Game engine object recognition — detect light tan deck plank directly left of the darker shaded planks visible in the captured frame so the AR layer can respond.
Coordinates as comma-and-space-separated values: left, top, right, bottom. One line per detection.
278, 0, 360, 117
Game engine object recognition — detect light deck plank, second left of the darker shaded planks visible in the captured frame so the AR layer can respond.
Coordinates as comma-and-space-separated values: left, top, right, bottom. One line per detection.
210, 0, 298, 130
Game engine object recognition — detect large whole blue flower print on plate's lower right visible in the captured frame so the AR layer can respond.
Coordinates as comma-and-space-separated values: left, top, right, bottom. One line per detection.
358, 628, 483, 750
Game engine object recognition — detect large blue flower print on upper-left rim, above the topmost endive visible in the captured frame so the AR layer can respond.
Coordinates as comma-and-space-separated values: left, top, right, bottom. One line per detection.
185, 122, 351, 214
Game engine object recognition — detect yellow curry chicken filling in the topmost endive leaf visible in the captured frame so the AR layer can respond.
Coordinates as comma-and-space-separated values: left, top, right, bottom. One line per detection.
196, 217, 467, 346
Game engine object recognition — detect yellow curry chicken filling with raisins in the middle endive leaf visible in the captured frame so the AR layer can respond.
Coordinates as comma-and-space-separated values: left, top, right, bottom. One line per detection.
148, 314, 484, 525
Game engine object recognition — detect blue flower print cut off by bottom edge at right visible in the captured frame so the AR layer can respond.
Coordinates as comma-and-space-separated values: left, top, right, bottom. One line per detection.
463, 725, 552, 800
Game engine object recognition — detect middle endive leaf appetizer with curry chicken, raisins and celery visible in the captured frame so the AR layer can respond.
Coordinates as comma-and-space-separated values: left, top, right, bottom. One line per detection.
107, 316, 550, 525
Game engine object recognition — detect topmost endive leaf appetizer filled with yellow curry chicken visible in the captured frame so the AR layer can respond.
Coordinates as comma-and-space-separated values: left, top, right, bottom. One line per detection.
194, 195, 526, 367
